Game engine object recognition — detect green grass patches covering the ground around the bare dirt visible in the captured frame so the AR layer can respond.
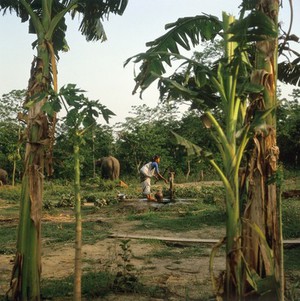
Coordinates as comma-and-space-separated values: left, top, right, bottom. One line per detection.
0, 178, 300, 301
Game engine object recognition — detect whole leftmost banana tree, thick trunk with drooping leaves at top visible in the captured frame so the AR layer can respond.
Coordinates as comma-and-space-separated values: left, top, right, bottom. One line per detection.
0, 0, 127, 300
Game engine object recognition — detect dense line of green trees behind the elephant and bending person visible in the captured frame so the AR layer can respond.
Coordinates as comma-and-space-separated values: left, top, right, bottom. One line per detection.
0, 89, 300, 180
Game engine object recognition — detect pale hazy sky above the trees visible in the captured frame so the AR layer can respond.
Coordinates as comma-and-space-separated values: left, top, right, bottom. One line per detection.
0, 0, 300, 125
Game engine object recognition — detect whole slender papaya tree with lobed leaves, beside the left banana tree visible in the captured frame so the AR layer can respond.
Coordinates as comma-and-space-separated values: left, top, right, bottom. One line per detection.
42, 84, 114, 301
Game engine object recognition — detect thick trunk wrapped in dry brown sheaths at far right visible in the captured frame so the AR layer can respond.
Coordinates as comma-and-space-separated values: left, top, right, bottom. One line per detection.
243, 0, 284, 300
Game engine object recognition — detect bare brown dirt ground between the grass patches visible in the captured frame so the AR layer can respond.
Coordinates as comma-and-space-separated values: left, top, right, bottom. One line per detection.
0, 191, 225, 301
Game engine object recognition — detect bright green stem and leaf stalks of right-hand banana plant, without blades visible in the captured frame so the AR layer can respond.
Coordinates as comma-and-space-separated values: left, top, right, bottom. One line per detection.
206, 13, 248, 300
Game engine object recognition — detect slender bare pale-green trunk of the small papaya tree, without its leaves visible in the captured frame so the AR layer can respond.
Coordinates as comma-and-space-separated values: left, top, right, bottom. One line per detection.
73, 142, 82, 301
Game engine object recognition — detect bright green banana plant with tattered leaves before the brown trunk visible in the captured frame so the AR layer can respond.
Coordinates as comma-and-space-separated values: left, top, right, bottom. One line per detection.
125, 7, 277, 300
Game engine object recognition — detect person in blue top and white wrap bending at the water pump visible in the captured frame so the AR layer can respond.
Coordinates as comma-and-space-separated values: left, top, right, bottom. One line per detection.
140, 155, 168, 201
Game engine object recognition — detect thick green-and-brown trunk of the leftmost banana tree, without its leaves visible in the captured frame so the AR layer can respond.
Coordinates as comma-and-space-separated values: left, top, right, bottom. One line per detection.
10, 44, 50, 300
